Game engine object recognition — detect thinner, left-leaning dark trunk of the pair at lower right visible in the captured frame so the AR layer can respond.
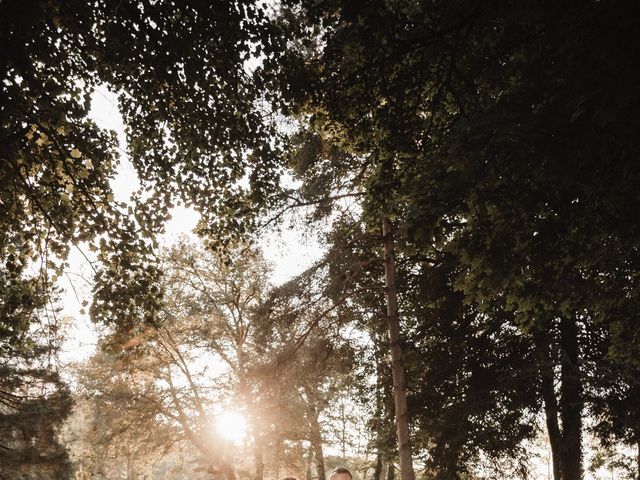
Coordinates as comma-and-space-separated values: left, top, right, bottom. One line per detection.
534, 332, 562, 480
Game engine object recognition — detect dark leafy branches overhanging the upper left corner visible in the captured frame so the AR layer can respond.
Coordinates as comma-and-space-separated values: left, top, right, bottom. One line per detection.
0, 1, 278, 474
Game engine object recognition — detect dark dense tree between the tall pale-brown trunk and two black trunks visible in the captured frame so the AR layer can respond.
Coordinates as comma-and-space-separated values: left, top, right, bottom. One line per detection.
401, 255, 540, 479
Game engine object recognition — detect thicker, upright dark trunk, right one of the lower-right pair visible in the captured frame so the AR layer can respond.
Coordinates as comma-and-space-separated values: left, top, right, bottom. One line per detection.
560, 318, 584, 480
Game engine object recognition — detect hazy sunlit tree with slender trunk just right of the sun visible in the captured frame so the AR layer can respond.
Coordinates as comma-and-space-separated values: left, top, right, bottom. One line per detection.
165, 242, 270, 480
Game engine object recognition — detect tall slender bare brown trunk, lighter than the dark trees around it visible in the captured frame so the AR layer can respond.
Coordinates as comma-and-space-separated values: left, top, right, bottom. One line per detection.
382, 216, 415, 480
